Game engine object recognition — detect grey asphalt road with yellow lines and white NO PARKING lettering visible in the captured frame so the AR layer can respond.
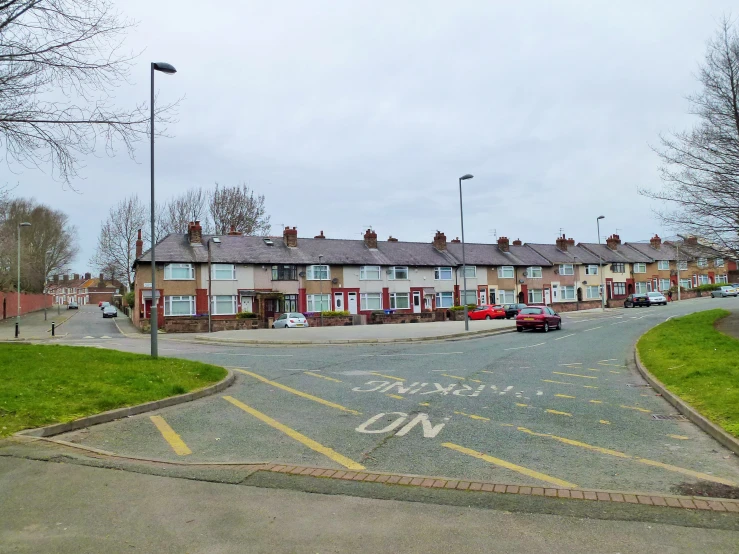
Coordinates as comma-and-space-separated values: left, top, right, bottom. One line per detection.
53, 298, 739, 493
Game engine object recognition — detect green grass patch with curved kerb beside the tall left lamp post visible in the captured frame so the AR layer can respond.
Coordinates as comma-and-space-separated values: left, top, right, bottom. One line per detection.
0, 344, 226, 437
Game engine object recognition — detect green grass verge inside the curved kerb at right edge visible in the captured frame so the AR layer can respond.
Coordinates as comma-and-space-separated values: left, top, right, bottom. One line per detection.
637, 310, 739, 437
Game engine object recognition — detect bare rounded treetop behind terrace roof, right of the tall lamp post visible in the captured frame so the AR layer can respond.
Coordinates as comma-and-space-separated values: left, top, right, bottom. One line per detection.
208, 183, 271, 235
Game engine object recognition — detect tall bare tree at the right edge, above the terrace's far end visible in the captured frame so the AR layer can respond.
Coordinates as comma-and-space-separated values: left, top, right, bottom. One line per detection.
640, 17, 739, 254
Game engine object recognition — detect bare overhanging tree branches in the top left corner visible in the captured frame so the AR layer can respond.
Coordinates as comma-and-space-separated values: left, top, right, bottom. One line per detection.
0, 0, 179, 181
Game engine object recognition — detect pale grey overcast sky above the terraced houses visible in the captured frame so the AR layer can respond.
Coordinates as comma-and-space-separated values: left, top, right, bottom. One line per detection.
8, 0, 735, 272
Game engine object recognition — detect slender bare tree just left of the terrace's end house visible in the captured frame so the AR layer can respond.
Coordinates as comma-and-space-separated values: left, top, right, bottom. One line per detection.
90, 195, 149, 288
